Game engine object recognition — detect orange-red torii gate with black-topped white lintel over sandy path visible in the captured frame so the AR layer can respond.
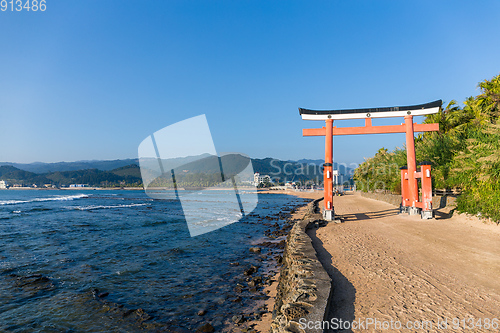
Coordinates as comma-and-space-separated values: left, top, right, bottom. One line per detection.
299, 100, 443, 221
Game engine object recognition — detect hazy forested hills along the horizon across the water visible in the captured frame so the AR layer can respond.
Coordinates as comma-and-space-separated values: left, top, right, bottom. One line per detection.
0, 155, 352, 186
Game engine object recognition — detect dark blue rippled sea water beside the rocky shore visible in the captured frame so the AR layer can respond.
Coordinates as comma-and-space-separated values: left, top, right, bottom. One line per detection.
0, 190, 307, 332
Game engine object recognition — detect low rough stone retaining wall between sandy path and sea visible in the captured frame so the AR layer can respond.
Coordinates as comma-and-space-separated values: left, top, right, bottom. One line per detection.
270, 199, 331, 333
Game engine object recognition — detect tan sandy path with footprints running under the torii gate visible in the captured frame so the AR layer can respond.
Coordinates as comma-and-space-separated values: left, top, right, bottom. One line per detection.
308, 194, 500, 332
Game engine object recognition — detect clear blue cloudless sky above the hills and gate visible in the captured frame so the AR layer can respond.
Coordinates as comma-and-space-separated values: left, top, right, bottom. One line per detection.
0, 0, 500, 163
